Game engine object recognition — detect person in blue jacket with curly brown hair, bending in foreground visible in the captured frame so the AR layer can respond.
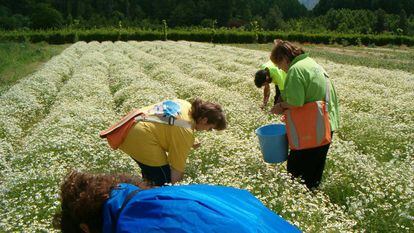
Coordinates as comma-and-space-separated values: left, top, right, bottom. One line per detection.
54, 171, 300, 233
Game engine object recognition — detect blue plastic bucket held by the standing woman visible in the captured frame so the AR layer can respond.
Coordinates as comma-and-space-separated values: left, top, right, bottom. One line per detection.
255, 124, 288, 163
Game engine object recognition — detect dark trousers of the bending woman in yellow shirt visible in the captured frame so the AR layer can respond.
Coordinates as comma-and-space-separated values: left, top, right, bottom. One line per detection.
135, 160, 171, 186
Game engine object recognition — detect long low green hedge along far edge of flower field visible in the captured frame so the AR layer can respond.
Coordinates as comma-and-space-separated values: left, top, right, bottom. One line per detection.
0, 29, 414, 46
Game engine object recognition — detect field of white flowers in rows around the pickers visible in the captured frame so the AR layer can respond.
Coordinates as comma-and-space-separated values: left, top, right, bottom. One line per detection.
0, 41, 414, 232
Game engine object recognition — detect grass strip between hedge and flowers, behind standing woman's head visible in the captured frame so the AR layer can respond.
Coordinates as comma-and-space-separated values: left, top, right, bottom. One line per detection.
230, 44, 414, 73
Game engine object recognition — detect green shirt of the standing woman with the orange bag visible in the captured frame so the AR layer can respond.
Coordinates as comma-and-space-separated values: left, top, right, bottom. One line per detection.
282, 54, 339, 131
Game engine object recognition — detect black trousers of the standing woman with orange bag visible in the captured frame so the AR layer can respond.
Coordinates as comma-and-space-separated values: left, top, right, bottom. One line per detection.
287, 133, 333, 189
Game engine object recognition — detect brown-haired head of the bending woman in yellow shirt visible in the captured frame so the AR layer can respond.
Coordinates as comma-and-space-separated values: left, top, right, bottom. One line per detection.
191, 98, 227, 131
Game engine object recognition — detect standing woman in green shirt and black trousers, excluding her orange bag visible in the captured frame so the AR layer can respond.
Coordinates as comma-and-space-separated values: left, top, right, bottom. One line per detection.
270, 40, 339, 189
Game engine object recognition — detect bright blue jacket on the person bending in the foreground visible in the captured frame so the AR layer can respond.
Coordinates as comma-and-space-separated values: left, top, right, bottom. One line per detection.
103, 184, 301, 233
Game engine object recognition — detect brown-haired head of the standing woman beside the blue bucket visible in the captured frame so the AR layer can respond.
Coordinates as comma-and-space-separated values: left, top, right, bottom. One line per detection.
270, 40, 305, 72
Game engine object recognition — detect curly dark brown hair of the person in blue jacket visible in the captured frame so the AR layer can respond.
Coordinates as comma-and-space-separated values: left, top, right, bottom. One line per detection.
53, 171, 142, 233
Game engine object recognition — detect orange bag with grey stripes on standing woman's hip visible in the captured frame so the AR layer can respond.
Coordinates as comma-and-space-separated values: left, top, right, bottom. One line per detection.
283, 101, 331, 150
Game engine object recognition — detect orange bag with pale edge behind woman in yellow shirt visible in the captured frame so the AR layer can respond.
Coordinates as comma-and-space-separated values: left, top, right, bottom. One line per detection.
99, 109, 142, 150
